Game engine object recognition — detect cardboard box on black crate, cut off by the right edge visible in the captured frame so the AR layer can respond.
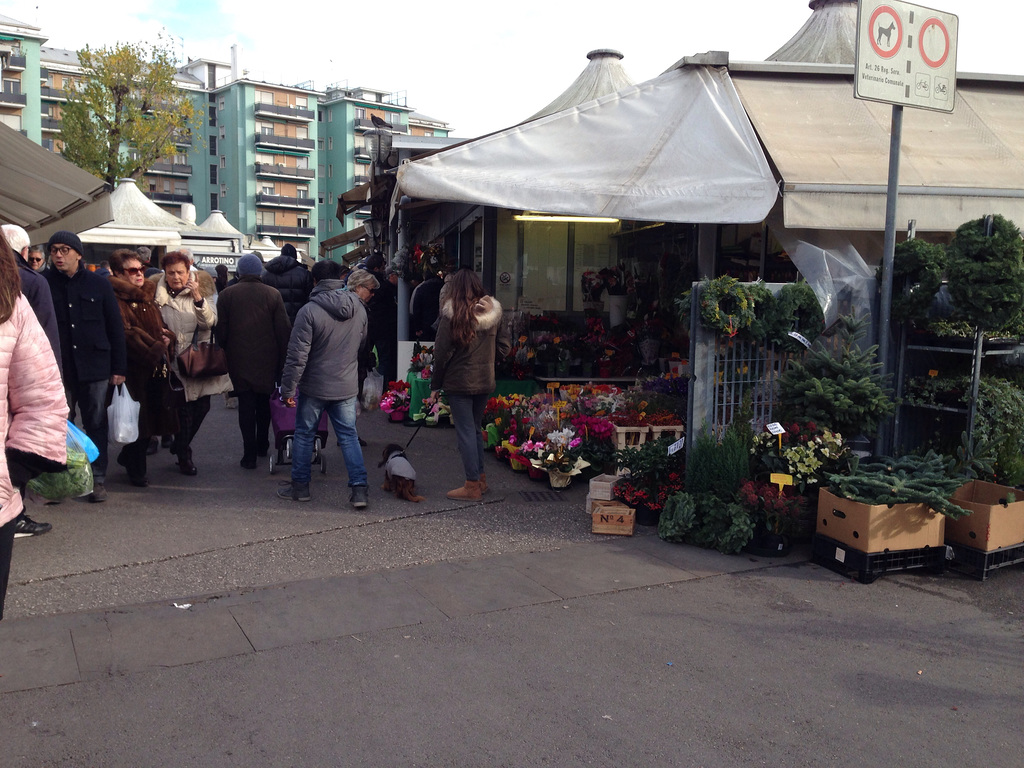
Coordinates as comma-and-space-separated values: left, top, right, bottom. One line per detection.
946, 480, 1024, 552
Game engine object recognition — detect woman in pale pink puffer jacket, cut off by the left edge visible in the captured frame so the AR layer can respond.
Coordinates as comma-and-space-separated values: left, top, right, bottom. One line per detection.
0, 234, 68, 618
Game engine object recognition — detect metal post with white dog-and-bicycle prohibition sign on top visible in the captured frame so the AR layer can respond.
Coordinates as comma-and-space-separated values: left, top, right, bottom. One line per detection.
854, 0, 958, 454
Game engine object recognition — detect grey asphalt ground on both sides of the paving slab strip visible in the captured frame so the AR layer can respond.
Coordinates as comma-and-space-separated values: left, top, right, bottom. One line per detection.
0, 403, 1024, 768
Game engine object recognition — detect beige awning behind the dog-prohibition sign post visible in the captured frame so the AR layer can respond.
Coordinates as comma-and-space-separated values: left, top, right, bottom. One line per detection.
732, 65, 1024, 231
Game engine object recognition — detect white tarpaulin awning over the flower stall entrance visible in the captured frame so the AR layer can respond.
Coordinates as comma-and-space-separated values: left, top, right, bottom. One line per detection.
398, 66, 778, 223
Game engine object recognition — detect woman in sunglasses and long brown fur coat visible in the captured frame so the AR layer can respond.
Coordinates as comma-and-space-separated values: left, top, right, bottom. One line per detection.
110, 248, 178, 487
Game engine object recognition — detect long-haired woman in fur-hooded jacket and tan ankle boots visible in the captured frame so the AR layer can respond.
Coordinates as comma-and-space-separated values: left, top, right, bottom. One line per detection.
430, 269, 512, 501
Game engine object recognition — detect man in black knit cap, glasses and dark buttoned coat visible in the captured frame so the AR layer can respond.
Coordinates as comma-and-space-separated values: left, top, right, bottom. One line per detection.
44, 230, 128, 502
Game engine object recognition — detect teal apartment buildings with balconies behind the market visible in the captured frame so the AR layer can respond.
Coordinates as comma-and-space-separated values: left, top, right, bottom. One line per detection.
0, 15, 450, 257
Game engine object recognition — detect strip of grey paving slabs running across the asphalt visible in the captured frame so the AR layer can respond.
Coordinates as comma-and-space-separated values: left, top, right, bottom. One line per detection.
0, 529, 808, 692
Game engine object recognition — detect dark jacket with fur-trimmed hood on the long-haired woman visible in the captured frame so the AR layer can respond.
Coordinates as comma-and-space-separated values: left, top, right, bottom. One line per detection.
430, 296, 512, 394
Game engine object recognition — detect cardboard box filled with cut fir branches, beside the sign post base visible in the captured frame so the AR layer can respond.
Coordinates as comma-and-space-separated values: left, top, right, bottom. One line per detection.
816, 488, 946, 553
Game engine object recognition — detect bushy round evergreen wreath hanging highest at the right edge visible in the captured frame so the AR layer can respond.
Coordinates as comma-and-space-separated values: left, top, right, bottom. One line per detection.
948, 215, 1024, 331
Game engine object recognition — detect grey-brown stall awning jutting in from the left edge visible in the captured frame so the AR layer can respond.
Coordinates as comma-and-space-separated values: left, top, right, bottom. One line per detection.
0, 125, 114, 243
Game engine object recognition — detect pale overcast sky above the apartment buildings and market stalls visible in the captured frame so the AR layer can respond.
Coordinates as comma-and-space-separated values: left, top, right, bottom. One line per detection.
8, 0, 1024, 137
